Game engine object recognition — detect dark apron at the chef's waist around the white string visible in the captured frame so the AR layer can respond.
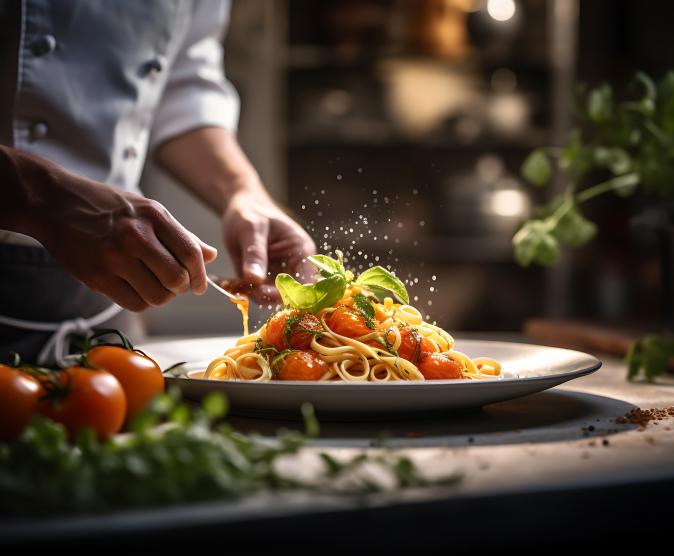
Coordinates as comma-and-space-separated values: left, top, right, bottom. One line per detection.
0, 243, 145, 363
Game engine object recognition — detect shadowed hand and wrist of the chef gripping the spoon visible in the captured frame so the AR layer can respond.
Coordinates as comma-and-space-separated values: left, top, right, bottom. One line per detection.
3, 151, 217, 312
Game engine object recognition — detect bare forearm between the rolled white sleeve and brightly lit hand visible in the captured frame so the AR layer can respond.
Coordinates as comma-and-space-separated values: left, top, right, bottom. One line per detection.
156, 127, 269, 214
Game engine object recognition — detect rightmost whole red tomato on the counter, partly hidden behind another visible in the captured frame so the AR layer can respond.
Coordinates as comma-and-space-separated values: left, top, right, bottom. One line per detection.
87, 346, 165, 421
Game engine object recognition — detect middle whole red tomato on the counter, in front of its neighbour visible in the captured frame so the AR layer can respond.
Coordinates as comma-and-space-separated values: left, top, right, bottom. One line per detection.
38, 366, 126, 440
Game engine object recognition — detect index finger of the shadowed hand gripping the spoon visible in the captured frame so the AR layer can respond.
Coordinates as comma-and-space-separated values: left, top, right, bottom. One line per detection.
152, 207, 207, 295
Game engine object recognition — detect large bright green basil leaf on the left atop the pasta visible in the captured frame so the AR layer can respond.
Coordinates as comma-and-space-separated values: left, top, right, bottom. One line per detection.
276, 274, 346, 314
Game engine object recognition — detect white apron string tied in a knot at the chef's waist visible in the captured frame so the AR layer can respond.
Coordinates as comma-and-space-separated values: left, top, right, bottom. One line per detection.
0, 303, 122, 368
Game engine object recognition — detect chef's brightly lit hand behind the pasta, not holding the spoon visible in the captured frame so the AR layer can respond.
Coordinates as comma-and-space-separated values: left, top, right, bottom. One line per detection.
222, 189, 316, 303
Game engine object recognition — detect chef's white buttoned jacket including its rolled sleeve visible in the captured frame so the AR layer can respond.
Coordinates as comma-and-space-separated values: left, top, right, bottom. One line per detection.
0, 0, 239, 245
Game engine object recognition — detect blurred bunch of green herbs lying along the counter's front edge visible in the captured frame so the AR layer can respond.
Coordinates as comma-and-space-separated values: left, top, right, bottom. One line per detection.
0, 388, 452, 518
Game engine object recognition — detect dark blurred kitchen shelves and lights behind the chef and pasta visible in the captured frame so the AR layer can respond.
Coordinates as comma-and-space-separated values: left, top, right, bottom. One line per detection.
142, 0, 674, 335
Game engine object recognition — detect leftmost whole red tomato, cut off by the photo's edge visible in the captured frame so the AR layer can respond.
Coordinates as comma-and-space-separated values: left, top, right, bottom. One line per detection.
0, 365, 42, 442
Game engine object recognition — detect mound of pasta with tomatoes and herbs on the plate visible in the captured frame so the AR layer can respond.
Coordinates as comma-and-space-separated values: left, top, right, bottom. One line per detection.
203, 257, 504, 382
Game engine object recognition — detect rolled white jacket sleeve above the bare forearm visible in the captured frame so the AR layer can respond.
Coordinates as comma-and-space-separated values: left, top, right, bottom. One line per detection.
150, 0, 240, 151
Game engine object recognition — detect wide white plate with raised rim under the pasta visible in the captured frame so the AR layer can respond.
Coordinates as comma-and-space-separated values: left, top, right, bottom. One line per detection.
140, 337, 601, 420
